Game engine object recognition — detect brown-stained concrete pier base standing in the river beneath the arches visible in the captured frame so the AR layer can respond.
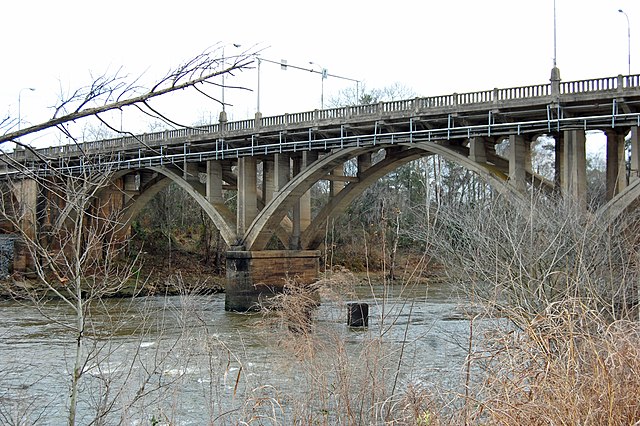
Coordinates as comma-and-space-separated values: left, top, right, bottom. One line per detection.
225, 250, 320, 312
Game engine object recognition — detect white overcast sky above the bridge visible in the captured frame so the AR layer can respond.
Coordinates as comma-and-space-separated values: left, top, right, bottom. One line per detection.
0, 0, 640, 151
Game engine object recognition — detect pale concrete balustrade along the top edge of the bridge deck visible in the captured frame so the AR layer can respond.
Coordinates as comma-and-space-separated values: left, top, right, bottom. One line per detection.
9, 75, 640, 161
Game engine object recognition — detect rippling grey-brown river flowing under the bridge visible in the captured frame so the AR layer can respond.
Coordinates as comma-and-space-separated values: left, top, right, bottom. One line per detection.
0, 284, 480, 425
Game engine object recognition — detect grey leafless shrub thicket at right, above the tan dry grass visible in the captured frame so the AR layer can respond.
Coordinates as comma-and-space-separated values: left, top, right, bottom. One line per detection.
409, 194, 637, 325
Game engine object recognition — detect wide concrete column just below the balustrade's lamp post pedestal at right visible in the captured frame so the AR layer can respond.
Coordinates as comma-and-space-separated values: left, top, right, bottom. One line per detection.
562, 130, 587, 208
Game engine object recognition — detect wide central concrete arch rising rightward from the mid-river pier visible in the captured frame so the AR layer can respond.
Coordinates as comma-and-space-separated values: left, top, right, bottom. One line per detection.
241, 142, 523, 250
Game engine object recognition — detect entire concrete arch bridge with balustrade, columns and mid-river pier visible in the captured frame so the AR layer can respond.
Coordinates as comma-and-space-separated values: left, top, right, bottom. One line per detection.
0, 69, 640, 310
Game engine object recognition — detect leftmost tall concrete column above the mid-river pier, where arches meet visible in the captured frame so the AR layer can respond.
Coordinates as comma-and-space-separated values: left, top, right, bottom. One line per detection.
237, 157, 258, 235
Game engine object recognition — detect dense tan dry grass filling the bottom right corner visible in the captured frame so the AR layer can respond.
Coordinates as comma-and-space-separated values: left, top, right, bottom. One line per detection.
470, 302, 640, 425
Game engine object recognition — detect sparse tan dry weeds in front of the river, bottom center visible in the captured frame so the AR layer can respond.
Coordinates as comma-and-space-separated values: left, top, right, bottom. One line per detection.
255, 270, 434, 425
